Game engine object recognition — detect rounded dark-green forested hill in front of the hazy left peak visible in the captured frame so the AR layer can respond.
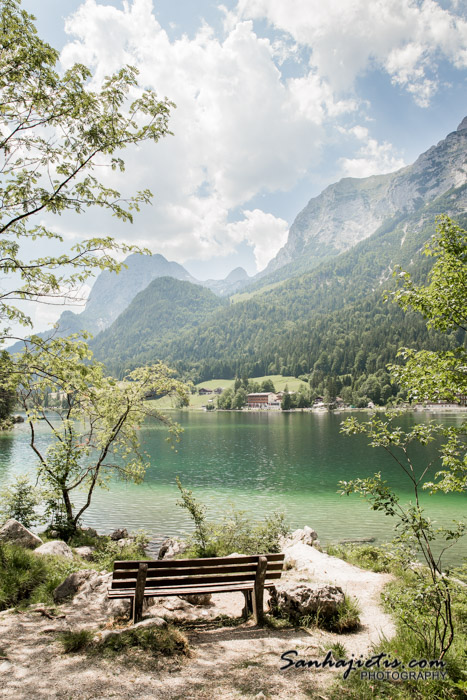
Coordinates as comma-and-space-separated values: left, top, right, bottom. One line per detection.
90, 277, 228, 373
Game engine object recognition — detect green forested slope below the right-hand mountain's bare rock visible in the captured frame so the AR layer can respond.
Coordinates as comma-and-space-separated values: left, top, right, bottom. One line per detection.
102, 185, 467, 380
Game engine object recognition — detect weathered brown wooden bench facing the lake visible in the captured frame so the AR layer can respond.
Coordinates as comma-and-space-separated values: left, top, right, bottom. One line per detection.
108, 554, 284, 625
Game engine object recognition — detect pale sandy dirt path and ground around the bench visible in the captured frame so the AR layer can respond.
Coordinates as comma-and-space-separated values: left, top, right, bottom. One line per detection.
0, 544, 393, 700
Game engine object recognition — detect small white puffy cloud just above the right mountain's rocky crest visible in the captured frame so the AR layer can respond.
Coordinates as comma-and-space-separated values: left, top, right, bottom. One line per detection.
339, 125, 405, 177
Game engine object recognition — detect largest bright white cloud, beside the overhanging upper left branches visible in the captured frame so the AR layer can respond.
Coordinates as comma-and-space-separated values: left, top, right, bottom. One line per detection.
57, 0, 356, 266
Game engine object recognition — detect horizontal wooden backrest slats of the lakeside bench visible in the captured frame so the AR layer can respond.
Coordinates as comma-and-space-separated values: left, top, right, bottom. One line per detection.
111, 554, 284, 590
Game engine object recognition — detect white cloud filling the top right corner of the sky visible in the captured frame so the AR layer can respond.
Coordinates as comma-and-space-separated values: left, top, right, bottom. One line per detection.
237, 0, 467, 106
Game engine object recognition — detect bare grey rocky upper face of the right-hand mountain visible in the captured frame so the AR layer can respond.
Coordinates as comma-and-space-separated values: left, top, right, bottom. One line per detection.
253, 117, 467, 288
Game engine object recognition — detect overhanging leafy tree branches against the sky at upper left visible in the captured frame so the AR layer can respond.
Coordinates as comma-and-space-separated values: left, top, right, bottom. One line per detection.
0, 0, 173, 340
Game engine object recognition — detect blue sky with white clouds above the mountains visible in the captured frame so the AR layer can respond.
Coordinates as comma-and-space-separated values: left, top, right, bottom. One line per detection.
12, 0, 467, 330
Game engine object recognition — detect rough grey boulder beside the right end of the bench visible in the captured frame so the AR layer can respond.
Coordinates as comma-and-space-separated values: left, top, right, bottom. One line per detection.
269, 582, 345, 620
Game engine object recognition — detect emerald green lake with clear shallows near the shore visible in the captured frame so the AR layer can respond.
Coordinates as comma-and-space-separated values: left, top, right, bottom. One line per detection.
0, 411, 467, 563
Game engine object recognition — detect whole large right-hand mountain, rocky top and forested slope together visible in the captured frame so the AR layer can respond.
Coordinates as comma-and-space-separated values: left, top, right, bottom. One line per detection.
93, 111, 467, 381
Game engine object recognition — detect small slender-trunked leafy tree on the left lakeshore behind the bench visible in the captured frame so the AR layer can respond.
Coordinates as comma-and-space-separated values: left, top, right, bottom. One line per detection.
11, 338, 188, 539
